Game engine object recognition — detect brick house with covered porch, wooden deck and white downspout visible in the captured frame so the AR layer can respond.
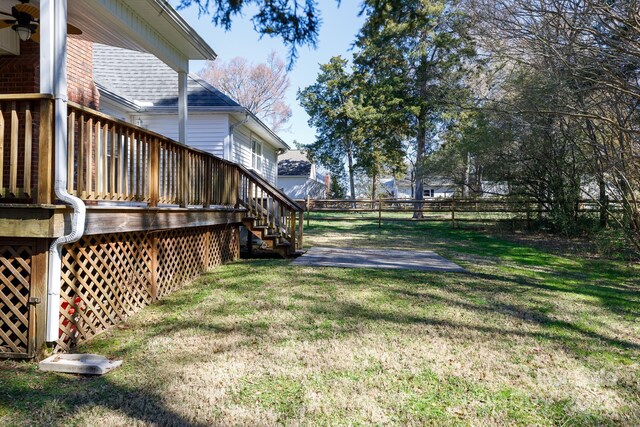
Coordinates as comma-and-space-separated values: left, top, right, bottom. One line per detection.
0, 0, 302, 358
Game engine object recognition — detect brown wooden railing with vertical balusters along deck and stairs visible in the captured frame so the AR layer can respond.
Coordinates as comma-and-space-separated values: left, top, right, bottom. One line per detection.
0, 94, 303, 248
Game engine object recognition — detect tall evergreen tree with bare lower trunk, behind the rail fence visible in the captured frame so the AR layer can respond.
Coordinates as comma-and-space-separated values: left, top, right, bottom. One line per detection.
356, 0, 474, 217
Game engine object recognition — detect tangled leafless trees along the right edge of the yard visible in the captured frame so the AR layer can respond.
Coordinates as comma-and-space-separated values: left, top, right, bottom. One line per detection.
467, 0, 640, 249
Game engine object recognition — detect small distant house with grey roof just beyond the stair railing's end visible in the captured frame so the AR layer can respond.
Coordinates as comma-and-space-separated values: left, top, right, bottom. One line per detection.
278, 150, 329, 199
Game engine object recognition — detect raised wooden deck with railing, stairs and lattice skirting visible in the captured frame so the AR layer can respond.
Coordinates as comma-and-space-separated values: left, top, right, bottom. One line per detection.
0, 94, 303, 357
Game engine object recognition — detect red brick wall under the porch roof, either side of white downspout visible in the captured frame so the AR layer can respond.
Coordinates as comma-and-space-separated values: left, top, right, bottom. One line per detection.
0, 38, 100, 109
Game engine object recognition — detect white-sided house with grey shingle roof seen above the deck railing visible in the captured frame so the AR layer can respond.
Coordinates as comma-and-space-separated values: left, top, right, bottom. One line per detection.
93, 44, 289, 185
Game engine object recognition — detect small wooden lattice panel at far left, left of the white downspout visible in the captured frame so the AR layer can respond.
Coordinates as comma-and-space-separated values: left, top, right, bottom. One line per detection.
0, 244, 33, 355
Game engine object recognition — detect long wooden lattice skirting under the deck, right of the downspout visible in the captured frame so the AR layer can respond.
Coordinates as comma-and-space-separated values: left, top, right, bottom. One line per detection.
56, 226, 239, 351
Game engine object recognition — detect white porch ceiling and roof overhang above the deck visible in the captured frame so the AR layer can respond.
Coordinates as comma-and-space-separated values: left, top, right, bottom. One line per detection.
0, 0, 216, 71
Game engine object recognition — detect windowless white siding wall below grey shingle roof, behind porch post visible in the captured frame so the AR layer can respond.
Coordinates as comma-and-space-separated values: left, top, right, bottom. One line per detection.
139, 113, 229, 157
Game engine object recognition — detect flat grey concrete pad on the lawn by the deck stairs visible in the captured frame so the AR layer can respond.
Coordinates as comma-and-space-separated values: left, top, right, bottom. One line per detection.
291, 247, 466, 272
